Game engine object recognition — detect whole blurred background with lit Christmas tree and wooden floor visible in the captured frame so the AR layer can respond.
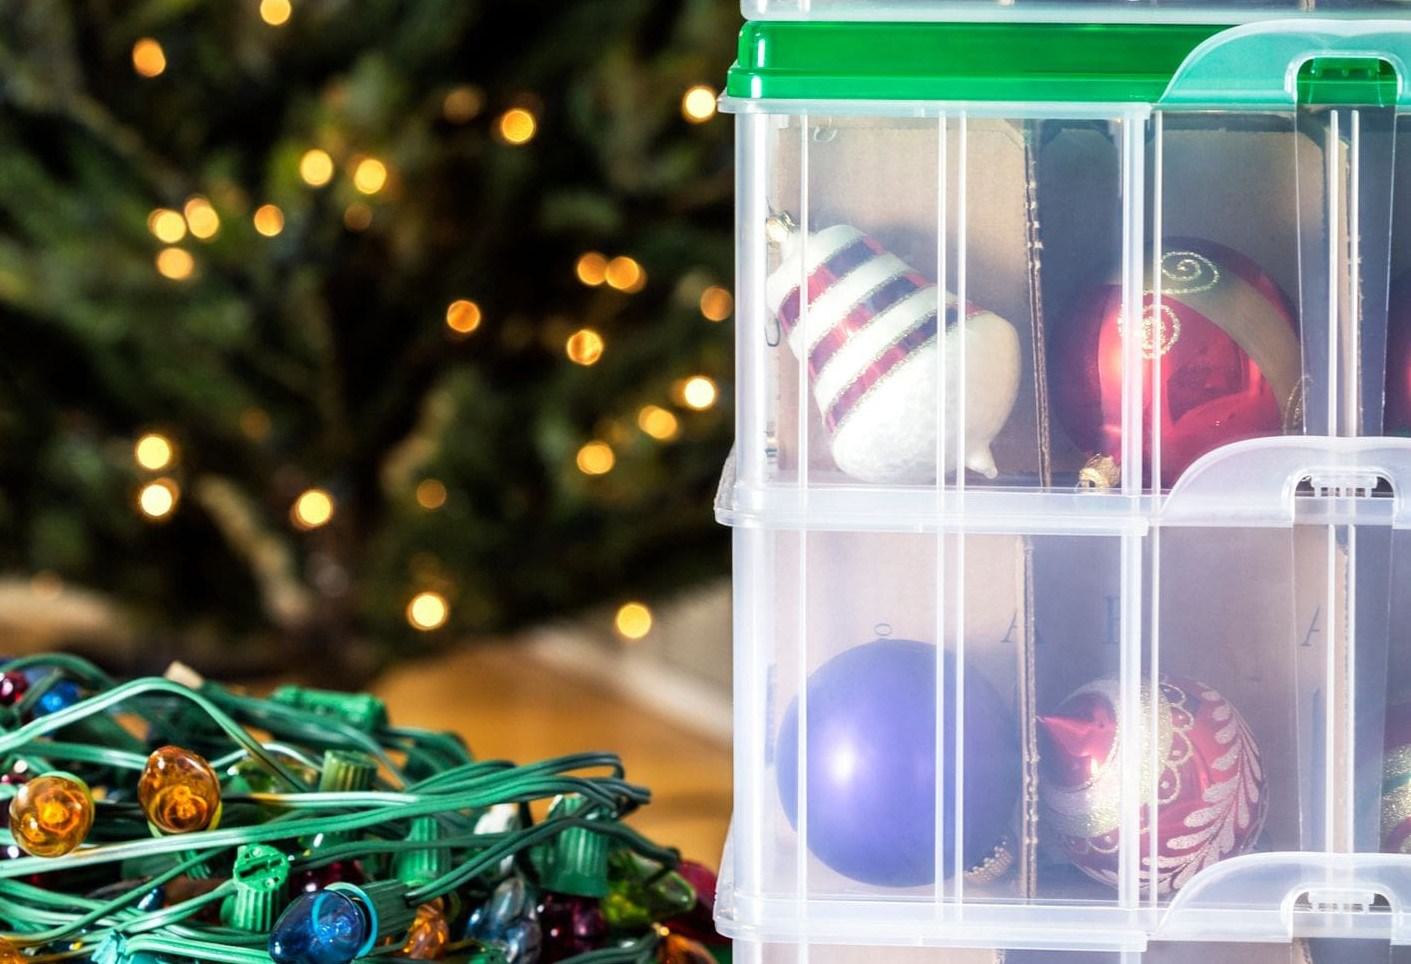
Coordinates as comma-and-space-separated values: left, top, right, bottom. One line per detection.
0, 0, 739, 861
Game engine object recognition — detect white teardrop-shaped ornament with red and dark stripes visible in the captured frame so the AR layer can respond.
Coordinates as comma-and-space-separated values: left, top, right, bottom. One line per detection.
766, 224, 1019, 483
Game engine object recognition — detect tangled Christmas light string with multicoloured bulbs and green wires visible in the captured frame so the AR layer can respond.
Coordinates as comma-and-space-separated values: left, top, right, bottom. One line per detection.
0, 653, 718, 964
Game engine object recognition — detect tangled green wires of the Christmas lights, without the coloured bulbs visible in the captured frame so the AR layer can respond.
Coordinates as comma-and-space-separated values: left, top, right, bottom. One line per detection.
0, 653, 705, 964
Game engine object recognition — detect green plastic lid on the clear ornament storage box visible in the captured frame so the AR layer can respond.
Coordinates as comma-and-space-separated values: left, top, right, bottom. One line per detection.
724, 21, 1411, 110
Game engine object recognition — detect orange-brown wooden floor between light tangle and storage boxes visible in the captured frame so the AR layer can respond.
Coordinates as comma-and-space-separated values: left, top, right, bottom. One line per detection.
374, 645, 731, 867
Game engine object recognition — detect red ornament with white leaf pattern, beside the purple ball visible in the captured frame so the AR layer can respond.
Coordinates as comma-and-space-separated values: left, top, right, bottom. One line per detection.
1040, 677, 1267, 896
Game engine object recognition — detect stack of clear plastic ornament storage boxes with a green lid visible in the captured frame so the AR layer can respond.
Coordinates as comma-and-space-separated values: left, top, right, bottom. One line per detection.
717, 0, 1411, 964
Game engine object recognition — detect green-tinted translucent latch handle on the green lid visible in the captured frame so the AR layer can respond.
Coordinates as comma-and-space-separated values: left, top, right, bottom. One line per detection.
1158, 20, 1411, 109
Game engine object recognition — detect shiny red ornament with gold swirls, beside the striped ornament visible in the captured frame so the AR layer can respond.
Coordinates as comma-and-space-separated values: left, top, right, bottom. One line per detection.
1050, 239, 1302, 487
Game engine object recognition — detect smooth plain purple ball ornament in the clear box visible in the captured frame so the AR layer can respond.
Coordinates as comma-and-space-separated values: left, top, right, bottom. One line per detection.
776, 638, 1022, 886
